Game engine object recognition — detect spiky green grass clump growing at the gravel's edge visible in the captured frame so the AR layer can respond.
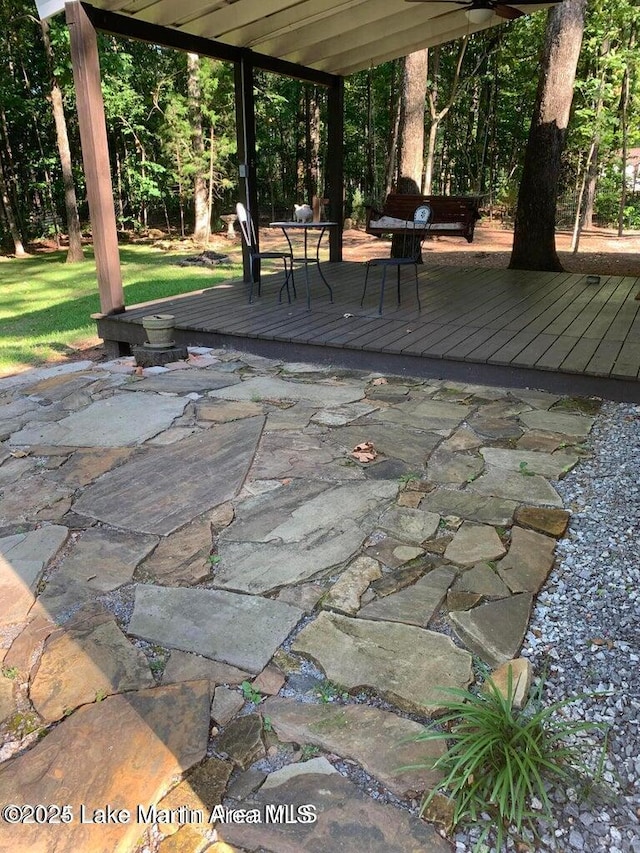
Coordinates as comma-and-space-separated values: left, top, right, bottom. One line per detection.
416, 669, 604, 850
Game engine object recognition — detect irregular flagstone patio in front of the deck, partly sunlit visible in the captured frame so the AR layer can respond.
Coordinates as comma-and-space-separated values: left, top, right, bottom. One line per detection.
0, 350, 594, 853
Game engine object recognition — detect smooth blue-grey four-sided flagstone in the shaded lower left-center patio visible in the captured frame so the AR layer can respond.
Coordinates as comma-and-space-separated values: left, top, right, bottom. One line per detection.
129, 585, 302, 673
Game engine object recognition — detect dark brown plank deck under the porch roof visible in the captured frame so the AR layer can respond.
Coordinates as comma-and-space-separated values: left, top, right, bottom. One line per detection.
98, 262, 640, 401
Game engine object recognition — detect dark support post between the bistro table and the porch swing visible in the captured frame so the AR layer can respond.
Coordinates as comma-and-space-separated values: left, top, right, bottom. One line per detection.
326, 77, 344, 261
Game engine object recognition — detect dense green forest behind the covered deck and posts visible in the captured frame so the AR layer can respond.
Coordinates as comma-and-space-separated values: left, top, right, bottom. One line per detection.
0, 0, 640, 253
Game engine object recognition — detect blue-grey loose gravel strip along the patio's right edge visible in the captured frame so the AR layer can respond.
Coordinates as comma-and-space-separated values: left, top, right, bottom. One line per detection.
456, 403, 640, 853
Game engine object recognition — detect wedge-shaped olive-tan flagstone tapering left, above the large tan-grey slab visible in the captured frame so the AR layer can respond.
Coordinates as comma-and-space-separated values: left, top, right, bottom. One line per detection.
358, 566, 456, 628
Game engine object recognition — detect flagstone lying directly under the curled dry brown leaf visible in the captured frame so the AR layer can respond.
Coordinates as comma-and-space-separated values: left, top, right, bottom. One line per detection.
327, 424, 440, 471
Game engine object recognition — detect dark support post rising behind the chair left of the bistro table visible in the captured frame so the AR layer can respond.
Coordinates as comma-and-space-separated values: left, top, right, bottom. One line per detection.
235, 54, 260, 281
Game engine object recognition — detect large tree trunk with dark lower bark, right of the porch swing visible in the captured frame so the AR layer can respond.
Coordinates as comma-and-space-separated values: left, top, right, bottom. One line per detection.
509, 0, 587, 270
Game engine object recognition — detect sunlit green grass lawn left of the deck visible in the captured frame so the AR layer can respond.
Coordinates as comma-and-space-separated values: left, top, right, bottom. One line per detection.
0, 240, 242, 375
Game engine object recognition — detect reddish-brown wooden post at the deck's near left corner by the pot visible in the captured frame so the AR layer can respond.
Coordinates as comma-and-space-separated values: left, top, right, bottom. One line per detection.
65, 0, 124, 314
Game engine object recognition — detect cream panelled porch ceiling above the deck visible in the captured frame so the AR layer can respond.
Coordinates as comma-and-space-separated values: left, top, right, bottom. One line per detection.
36, 0, 554, 75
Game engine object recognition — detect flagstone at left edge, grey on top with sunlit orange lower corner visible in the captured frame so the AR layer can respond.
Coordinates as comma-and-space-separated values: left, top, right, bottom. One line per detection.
0, 524, 69, 627
